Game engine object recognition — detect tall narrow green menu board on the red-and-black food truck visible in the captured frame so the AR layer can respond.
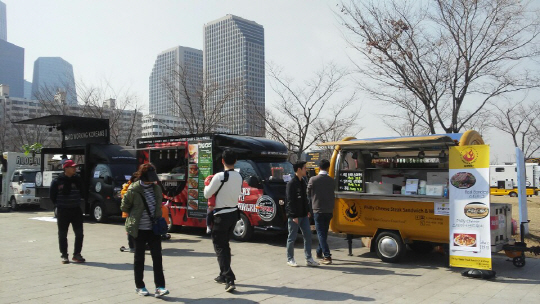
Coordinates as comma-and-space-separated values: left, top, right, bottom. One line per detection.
187, 142, 212, 218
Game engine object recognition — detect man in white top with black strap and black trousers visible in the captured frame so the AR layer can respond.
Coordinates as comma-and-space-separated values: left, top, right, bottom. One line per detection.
204, 149, 242, 292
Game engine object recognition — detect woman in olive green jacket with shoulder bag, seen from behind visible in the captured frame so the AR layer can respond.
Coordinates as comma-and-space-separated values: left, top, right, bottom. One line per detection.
120, 163, 169, 298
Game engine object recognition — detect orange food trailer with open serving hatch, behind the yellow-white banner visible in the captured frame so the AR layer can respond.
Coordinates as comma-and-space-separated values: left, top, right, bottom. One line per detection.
322, 130, 512, 262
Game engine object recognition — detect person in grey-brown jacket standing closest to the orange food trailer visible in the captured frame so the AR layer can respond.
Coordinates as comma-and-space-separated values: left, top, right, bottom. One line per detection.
308, 159, 335, 265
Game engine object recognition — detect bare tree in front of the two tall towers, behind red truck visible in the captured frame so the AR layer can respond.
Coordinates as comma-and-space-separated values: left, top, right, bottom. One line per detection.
161, 63, 242, 134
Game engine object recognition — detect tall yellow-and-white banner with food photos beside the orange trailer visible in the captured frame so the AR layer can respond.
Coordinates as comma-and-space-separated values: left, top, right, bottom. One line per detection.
448, 145, 491, 270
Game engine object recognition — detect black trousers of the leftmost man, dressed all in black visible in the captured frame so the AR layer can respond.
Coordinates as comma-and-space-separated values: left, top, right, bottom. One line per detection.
56, 208, 84, 256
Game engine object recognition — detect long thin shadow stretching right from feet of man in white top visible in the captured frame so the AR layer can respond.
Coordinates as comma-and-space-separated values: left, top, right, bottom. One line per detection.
235, 284, 375, 303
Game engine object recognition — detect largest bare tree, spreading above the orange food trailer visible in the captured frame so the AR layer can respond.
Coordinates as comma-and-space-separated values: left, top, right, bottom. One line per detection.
339, 0, 540, 134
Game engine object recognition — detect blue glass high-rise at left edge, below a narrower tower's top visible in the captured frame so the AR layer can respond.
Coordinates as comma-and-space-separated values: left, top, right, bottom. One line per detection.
0, 39, 24, 98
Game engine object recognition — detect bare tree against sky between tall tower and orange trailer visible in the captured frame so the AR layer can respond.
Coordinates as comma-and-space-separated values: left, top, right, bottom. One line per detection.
259, 64, 360, 159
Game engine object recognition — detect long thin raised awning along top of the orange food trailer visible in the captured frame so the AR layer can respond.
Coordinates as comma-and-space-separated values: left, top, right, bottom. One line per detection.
319, 133, 463, 150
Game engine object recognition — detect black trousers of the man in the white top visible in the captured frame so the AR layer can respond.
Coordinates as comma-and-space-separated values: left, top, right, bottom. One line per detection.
211, 211, 238, 282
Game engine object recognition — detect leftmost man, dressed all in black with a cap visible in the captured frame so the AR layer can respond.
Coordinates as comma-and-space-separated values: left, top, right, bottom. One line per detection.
50, 160, 86, 264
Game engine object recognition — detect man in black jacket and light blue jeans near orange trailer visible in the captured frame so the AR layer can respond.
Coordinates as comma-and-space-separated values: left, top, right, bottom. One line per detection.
285, 161, 319, 267
